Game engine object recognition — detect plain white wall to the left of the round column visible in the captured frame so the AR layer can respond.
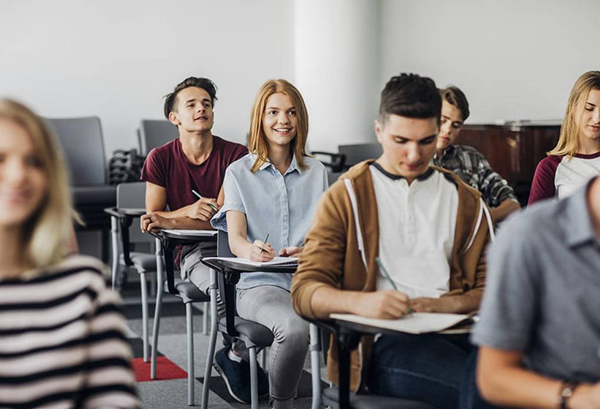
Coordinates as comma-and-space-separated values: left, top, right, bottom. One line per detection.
0, 0, 294, 153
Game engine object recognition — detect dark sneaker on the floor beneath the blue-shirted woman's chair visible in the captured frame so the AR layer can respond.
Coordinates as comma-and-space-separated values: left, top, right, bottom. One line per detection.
214, 348, 269, 403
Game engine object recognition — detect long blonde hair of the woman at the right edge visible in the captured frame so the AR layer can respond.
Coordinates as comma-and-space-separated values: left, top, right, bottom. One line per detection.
547, 71, 600, 157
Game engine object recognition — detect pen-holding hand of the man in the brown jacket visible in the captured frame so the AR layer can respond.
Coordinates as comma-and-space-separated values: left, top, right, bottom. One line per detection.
355, 290, 410, 320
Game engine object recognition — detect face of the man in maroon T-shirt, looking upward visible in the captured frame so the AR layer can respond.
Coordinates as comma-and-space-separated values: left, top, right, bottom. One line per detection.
169, 87, 214, 133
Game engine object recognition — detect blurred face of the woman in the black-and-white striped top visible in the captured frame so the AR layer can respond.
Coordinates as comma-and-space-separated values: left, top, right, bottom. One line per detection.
0, 119, 48, 228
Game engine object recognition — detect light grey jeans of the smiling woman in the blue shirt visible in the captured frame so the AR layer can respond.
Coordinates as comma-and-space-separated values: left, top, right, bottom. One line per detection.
237, 285, 309, 408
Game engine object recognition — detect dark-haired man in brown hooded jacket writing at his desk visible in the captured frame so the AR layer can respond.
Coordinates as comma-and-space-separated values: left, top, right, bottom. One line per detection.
292, 74, 492, 408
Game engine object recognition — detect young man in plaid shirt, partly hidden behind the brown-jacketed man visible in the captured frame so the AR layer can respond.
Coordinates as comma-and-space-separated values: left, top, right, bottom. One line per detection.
433, 86, 520, 223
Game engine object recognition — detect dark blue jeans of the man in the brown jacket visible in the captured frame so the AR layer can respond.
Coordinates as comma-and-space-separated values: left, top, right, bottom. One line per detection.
367, 334, 475, 409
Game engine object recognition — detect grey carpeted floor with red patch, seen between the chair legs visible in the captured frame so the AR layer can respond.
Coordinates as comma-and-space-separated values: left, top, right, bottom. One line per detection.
122, 285, 325, 409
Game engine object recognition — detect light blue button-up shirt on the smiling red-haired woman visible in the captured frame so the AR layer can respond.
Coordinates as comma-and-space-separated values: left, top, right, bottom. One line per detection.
211, 154, 328, 290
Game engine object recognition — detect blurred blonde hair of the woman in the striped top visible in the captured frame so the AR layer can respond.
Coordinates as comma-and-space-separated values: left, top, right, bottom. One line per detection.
0, 99, 74, 268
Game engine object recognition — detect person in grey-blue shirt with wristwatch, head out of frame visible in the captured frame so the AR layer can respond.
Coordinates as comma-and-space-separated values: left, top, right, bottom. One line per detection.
465, 176, 600, 409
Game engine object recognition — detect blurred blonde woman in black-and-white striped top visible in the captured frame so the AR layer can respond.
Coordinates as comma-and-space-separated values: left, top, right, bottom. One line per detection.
0, 100, 140, 409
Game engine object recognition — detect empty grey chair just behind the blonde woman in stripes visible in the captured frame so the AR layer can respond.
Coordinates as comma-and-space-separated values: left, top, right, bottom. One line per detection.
46, 117, 116, 260
